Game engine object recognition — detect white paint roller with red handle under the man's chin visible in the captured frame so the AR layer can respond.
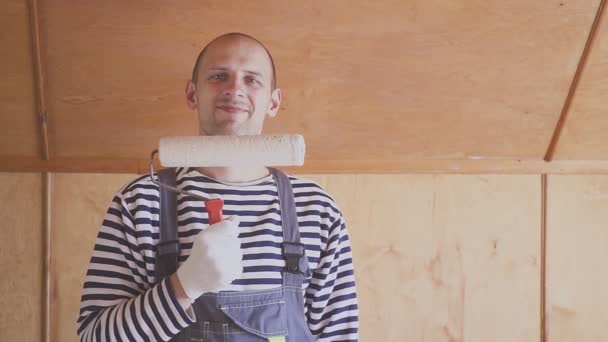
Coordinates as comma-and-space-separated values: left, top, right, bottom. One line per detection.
150, 134, 306, 224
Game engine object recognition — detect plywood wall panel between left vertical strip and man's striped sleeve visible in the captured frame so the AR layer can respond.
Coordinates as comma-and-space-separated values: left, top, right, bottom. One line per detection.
51, 174, 134, 342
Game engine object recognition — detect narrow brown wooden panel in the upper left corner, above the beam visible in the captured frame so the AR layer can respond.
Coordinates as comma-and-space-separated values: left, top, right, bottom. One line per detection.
0, 0, 40, 157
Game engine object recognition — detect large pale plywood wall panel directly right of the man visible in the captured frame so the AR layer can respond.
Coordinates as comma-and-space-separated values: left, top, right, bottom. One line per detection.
306, 175, 540, 342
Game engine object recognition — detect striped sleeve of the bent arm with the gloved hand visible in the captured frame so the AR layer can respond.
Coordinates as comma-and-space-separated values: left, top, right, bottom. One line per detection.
77, 194, 194, 341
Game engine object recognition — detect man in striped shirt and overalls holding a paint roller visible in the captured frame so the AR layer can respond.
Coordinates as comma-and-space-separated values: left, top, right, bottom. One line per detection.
77, 33, 358, 341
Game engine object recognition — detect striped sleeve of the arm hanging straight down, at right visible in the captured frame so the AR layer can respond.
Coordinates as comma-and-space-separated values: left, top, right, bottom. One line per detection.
305, 215, 359, 341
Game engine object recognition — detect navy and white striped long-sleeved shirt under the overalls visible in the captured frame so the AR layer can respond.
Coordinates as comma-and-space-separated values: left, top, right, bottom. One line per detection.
77, 168, 359, 341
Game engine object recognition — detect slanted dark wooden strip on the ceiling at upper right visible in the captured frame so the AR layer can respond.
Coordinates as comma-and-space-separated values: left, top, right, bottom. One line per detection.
544, 0, 606, 162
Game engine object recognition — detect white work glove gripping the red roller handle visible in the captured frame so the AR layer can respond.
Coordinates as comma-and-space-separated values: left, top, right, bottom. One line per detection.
176, 216, 243, 299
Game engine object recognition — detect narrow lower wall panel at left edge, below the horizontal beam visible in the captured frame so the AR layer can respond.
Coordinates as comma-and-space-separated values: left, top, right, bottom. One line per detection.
0, 173, 43, 341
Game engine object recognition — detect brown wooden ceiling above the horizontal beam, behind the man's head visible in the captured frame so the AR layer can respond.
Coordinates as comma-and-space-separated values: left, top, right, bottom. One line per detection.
0, 0, 608, 173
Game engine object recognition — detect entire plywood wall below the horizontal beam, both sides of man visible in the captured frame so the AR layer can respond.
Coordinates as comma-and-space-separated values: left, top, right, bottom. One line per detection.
0, 174, 608, 342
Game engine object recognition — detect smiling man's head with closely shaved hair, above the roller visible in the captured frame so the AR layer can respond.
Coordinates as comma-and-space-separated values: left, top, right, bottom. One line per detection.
186, 37, 281, 135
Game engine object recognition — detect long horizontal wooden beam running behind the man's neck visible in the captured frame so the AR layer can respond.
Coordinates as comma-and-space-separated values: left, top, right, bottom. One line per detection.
0, 157, 608, 174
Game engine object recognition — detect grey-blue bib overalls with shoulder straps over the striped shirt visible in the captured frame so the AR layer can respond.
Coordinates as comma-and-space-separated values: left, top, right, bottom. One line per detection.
156, 169, 315, 342
